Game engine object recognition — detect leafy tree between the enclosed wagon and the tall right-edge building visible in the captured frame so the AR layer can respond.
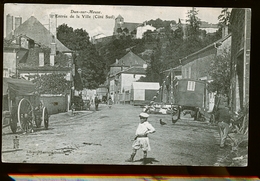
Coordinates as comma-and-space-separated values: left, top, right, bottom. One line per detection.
208, 48, 231, 95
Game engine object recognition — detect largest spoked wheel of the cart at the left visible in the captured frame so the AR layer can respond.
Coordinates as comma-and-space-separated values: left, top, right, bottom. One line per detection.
17, 98, 33, 132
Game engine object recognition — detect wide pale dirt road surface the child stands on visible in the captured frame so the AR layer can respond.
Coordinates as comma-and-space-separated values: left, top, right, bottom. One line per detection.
2, 104, 230, 166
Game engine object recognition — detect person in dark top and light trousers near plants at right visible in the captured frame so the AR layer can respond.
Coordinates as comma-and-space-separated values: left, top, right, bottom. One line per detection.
215, 102, 231, 148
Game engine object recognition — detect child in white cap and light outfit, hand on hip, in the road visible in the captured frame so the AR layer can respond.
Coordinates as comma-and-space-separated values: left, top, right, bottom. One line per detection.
126, 113, 155, 165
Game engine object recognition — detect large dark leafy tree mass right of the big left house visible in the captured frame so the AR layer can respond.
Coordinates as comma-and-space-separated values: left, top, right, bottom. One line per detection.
57, 24, 106, 90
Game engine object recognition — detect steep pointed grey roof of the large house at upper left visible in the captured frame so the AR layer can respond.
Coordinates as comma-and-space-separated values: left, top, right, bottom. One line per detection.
7, 16, 72, 52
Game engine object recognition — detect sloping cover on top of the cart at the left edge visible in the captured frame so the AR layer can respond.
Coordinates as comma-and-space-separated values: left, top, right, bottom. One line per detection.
3, 77, 35, 95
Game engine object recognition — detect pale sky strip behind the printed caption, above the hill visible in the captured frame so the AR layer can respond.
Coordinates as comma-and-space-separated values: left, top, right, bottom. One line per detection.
4, 3, 224, 37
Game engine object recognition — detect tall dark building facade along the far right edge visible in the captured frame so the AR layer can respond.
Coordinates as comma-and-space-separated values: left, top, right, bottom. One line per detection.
230, 9, 251, 112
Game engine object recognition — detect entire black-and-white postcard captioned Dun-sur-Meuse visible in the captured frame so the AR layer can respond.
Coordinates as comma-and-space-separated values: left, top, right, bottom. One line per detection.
1, 3, 251, 167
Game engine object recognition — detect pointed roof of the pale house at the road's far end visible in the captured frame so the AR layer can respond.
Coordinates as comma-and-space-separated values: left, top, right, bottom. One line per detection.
110, 51, 146, 67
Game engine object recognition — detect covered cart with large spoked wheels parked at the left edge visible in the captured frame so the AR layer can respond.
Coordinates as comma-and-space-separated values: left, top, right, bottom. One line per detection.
2, 78, 49, 133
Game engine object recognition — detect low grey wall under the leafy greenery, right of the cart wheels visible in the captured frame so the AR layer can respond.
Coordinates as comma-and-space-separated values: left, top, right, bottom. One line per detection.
40, 95, 68, 115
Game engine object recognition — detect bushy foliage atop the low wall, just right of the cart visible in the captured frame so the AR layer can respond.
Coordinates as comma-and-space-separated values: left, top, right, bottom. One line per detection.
33, 74, 71, 94
